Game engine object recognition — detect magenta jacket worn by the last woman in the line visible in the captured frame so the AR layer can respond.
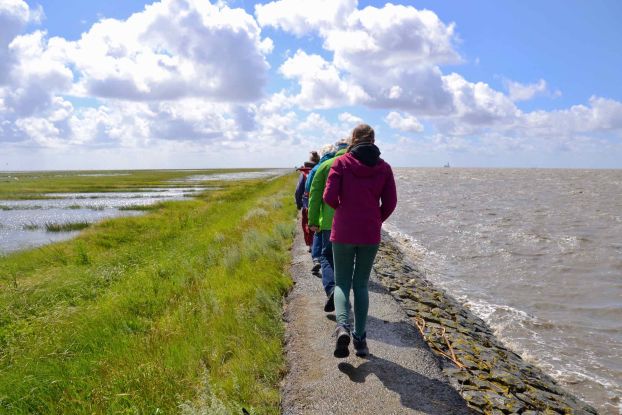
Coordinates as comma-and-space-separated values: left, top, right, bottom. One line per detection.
324, 145, 397, 244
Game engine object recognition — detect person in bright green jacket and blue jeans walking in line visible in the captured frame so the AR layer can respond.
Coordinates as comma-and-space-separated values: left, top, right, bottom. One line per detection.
309, 140, 348, 312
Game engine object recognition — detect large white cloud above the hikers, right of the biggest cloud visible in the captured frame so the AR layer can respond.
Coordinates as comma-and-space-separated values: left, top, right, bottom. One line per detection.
270, 0, 460, 115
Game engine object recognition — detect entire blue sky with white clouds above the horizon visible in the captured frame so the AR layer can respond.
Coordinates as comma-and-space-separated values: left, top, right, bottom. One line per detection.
0, 0, 622, 171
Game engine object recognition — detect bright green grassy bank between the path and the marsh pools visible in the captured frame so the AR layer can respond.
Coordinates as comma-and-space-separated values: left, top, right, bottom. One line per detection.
0, 175, 296, 414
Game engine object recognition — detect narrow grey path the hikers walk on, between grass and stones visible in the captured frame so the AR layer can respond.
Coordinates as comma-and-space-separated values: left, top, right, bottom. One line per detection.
282, 229, 471, 415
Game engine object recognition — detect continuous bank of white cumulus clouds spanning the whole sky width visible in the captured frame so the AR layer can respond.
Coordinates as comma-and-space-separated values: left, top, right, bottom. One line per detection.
0, 0, 622, 165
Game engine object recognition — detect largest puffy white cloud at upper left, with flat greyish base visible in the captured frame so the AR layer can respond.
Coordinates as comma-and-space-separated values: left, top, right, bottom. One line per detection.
58, 0, 272, 102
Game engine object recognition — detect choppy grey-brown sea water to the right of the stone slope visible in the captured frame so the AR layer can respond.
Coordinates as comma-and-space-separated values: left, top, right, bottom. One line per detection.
385, 168, 622, 414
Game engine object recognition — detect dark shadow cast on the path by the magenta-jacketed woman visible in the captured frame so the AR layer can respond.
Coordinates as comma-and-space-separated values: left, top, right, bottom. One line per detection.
337, 355, 472, 415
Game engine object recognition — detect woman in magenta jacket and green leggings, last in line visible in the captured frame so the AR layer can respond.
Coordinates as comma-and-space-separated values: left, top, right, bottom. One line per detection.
324, 124, 397, 357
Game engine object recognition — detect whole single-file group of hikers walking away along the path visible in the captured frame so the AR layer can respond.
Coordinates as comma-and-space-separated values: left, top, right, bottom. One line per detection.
295, 124, 397, 358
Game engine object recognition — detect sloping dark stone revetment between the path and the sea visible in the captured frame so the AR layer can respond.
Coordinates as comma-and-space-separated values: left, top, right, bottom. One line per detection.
374, 234, 597, 415
